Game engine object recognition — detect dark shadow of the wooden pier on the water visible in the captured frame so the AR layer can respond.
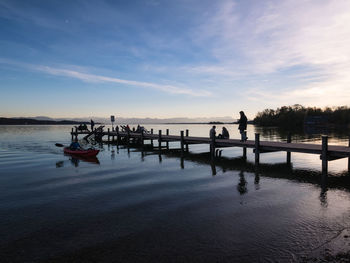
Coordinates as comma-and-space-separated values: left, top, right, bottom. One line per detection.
118, 141, 350, 194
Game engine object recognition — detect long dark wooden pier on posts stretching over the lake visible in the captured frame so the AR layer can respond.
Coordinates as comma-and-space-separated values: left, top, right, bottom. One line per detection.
71, 127, 350, 177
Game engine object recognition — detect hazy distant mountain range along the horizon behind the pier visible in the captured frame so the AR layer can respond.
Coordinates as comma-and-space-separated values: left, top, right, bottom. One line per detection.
0, 116, 237, 124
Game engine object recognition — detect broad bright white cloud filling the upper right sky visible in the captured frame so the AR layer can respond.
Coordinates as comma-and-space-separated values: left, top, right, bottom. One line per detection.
187, 0, 350, 106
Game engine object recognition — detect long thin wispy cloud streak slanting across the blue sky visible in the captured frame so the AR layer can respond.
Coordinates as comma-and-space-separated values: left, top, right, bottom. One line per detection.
0, 58, 212, 97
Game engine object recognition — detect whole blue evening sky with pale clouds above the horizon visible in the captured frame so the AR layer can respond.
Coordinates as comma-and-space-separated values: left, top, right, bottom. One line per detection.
0, 0, 350, 118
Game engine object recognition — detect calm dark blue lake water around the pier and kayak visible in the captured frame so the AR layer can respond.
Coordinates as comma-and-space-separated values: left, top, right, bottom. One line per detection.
0, 125, 350, 262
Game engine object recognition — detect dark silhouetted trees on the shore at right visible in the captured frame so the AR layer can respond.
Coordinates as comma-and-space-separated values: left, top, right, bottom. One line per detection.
254, 104, 350, 128
